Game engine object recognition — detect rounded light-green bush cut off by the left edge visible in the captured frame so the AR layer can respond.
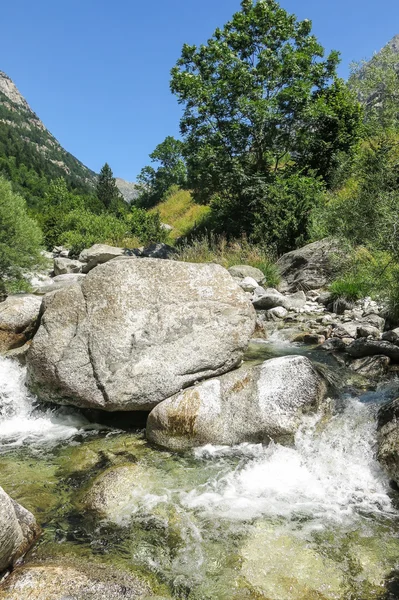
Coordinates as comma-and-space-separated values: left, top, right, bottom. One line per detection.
0, 177, 42, 288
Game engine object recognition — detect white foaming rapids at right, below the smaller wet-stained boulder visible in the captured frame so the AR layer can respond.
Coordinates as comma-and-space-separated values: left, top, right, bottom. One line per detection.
181, 399, 393, 529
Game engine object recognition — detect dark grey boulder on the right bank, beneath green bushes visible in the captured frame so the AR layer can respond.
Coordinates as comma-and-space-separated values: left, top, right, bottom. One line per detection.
277, 239, 342, 292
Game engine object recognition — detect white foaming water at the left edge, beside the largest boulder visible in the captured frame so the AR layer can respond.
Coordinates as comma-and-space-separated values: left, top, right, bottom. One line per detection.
0, 358, 98, 452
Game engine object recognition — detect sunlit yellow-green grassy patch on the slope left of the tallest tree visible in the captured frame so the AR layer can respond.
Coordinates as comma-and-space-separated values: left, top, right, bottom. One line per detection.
149, 188, 210, 243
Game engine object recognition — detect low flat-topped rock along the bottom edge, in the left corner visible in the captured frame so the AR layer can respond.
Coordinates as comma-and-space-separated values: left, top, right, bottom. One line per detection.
0, 560, 155, 600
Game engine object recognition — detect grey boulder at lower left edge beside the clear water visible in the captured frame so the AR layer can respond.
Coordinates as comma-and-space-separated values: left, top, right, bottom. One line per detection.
0, 487, 40, 572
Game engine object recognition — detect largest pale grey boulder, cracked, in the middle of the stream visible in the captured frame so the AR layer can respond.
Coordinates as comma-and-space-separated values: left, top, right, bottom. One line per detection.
27, 259, 256, 411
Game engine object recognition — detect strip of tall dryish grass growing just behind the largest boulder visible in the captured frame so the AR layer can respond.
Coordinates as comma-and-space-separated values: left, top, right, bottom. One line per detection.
176, 235, 280, 287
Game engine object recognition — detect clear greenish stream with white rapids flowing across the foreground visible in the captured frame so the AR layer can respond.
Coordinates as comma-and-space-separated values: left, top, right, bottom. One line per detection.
0, 345, 399, 600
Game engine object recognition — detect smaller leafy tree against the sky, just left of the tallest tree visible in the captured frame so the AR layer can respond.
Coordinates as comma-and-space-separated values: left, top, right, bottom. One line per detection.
137, 136, 187, 208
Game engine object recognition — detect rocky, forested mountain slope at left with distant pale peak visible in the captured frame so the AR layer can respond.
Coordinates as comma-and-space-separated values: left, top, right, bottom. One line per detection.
0, 71, 136, 202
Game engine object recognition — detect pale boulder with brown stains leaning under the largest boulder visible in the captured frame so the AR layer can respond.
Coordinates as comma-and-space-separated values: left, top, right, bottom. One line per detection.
147, 356, 326, 450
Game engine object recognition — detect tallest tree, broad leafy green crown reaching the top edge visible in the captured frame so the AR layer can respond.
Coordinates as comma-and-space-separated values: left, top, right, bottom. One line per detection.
171, 0, 361, 247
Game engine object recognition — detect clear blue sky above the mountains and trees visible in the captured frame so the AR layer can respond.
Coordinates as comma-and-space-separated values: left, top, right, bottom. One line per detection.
0, 0, 399, 181
